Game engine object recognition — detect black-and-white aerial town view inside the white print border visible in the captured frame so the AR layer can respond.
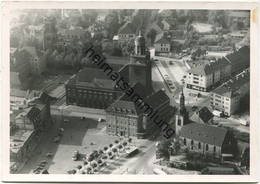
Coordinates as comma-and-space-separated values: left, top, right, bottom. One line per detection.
8, 9, 250, 175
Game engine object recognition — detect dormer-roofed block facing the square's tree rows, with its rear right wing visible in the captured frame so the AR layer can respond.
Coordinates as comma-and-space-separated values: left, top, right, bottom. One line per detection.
106, 83, 174, 138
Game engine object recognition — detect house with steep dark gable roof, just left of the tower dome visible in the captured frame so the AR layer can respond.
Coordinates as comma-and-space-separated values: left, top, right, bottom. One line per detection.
118, 21, 136, 41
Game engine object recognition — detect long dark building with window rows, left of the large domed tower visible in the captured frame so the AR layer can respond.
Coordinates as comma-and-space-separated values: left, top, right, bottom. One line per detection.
65, 68, 122, 109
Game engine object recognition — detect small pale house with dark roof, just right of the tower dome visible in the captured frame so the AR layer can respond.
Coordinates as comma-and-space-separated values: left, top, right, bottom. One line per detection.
154, 33, 171, 53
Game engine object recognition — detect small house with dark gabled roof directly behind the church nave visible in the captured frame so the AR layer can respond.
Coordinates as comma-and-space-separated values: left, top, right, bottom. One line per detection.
190, 107, 214, 124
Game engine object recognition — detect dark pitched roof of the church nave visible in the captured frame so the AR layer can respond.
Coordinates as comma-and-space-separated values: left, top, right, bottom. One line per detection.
180, 123, 227, 146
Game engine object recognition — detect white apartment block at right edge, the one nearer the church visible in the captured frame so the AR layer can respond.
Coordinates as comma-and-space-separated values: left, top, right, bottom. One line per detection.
210, 69, 249, 116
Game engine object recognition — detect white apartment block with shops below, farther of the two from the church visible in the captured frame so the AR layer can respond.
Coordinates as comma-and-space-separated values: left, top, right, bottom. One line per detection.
185, 60, 231, 92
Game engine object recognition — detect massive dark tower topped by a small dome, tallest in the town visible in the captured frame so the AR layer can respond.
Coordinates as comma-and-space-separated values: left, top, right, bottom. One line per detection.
129, 31, 152, 92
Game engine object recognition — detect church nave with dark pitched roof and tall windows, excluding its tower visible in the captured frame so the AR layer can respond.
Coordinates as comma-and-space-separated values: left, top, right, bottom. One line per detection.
179, 123, 236, 158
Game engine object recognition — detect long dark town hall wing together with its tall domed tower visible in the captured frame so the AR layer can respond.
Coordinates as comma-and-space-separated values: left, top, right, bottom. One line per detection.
65, 30, 152, 109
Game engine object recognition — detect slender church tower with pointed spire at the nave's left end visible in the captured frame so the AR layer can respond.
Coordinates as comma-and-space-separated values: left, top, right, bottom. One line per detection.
175, 90, 189, 135
